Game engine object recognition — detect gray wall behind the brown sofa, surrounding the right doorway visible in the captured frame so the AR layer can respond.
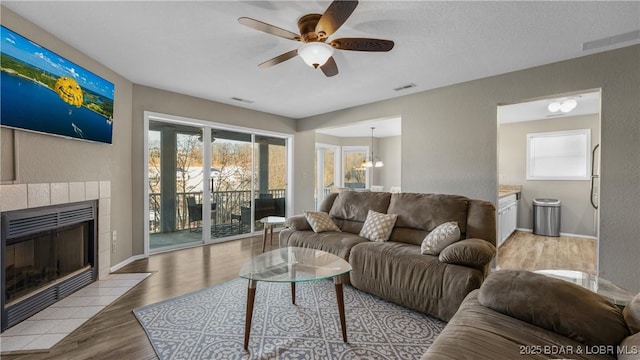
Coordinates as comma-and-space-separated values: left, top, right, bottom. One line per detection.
296, 45, 640, 291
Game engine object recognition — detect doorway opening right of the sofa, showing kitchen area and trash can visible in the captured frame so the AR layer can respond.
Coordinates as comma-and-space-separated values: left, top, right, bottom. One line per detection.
496, 89, 601, 275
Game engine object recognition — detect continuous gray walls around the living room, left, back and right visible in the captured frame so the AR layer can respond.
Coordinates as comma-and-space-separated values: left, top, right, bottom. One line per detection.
0, 7, 640, 291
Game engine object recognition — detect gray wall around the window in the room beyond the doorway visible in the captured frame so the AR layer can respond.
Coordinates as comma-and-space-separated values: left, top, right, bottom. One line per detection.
498, 114, 600, 236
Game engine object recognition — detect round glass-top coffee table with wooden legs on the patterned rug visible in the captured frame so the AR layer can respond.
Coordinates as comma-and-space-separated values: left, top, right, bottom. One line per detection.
240, 247, 351, 350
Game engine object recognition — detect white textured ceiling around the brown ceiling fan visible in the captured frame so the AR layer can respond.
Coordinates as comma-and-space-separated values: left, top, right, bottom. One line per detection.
2, 1, 640, 123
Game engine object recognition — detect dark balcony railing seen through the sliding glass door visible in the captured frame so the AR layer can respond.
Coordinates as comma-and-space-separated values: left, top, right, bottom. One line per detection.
149, 189, 285, 234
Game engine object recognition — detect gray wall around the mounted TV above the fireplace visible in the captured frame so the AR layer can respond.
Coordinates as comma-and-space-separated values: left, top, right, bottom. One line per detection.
0, 7, 133, 266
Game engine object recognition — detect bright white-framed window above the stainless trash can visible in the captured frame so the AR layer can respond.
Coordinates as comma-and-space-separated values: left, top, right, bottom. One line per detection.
527, 129, 591, 180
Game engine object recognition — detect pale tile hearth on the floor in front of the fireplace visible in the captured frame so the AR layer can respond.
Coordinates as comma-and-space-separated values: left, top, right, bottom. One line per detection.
0, 273, 151, 353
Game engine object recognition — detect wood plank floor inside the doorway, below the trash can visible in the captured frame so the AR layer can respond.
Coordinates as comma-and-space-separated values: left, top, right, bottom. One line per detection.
497, 231, 597, 275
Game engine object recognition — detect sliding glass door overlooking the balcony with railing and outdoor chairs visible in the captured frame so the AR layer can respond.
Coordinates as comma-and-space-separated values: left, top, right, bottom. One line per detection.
147, 119, 289, 252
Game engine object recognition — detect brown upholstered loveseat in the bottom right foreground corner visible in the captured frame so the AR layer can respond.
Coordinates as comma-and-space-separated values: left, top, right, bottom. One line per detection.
422, 270, 640, 360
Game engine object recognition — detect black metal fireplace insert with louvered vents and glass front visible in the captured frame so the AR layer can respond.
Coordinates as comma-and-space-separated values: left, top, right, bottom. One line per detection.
0, 201, 98, 331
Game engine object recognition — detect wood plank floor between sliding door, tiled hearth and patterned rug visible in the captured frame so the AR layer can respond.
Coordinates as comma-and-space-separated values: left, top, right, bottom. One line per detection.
2, 235, 277, 360
